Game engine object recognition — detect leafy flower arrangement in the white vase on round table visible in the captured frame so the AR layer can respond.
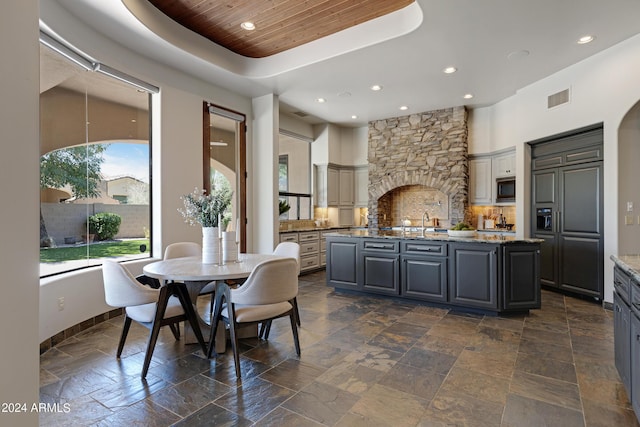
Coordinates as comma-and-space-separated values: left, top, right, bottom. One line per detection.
178, 187, 233, 227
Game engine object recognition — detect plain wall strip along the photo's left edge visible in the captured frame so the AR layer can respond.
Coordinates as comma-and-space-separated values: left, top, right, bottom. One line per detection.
0, 0, 40, 426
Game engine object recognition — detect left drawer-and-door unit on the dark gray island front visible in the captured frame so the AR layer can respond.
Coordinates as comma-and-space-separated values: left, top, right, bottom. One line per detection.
359, 239, 400, 295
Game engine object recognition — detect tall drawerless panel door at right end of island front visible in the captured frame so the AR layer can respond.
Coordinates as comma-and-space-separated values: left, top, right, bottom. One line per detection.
449, 243, 500, 311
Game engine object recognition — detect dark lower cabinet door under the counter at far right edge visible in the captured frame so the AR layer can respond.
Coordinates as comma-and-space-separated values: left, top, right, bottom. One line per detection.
613, 293, 640, 396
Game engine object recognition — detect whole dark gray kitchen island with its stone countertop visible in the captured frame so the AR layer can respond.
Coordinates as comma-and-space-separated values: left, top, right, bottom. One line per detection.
326, 230, 540, 313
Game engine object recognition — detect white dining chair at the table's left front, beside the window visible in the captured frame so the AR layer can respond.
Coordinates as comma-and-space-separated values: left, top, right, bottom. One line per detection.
102, 261, 207, 378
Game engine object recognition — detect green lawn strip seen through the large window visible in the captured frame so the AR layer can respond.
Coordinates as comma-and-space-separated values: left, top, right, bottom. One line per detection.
40, 239, 149, 262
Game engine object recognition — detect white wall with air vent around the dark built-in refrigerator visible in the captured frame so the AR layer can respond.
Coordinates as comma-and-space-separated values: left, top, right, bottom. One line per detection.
472, 35, 640, 302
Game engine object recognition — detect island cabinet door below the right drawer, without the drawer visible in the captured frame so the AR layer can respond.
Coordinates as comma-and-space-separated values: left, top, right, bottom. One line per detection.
400, 255, 448, 302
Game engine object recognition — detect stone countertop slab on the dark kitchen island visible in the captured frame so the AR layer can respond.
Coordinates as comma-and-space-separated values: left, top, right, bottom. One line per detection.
326, 229, 543, 244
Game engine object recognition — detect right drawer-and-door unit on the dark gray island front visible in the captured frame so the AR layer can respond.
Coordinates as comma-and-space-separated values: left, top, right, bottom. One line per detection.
400, 242, 448, 302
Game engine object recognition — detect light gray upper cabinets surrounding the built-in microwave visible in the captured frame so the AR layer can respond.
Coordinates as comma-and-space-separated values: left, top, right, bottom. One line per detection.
469, 149, 516, 205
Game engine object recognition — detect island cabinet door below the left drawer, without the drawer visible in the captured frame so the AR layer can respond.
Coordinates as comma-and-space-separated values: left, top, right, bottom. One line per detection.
361, 252, 400, 295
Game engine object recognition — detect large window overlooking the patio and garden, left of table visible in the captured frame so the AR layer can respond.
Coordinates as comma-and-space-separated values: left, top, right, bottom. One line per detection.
40, 35, 151, 277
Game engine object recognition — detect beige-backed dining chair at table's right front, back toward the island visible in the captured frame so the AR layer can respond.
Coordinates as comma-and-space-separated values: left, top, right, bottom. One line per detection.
207, 258, 300, 378
